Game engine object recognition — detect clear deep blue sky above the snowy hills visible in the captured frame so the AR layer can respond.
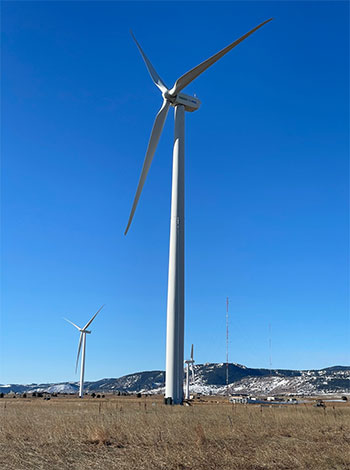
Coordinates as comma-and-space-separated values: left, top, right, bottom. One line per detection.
0, 1, 350, 383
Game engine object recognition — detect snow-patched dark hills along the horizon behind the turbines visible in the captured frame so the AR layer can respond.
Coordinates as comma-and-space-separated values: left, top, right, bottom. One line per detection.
0, 363, 350, 395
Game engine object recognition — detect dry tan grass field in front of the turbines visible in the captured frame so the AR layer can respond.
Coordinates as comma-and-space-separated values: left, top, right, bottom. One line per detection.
0, 397, 350, 470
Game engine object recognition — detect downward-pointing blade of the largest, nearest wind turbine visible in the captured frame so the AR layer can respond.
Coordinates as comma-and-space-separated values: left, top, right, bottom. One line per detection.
124, 100, 170, 235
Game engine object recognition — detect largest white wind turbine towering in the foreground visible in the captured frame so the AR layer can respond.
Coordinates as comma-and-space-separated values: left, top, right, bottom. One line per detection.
125, 18, 272, 404
